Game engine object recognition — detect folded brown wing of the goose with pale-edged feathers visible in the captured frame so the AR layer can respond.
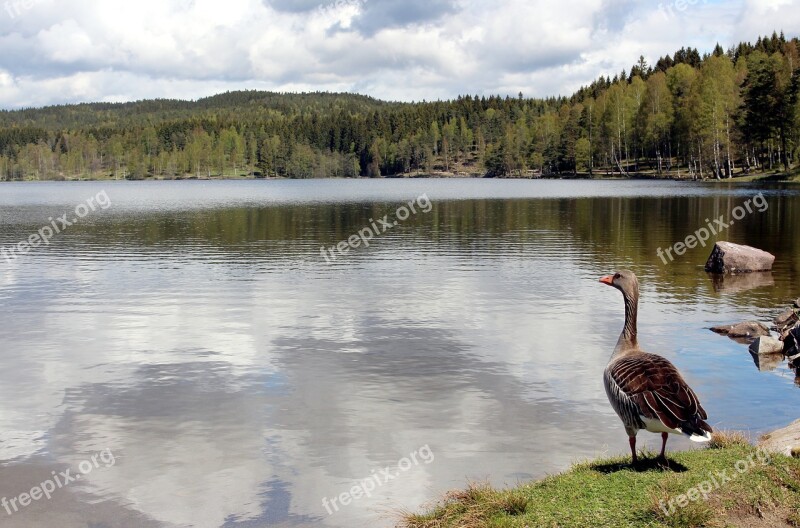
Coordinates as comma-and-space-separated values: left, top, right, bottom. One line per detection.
608, 354, 711, 437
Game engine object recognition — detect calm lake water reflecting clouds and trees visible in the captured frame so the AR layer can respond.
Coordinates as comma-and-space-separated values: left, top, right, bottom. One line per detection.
0, 180, 800, 527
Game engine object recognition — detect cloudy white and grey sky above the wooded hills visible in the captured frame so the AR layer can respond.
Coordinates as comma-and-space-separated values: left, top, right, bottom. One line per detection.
0, 0, 800, 109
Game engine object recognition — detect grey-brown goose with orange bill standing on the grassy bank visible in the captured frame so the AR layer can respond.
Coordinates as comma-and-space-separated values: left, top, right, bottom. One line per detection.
600, 270, 712, 465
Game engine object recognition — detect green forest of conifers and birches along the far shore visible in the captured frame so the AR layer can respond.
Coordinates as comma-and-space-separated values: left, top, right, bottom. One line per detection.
0, 33, 800, 181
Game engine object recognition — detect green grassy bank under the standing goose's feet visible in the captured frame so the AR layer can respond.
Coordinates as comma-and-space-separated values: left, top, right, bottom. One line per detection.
399, 433, 800, 528
